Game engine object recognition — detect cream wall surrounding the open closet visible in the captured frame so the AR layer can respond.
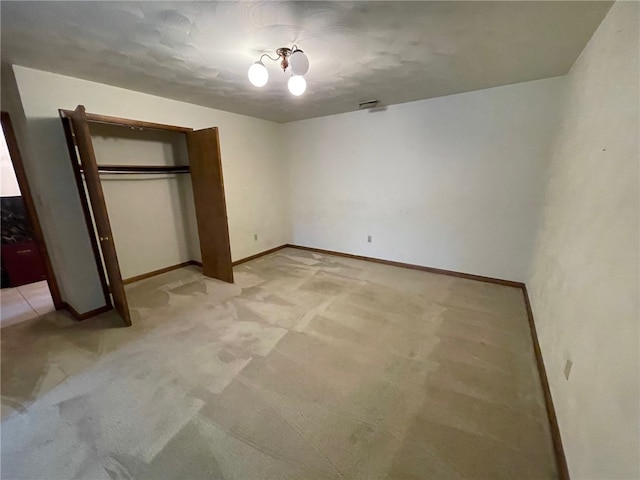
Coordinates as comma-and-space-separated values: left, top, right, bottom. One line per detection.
13, 66, 290, 312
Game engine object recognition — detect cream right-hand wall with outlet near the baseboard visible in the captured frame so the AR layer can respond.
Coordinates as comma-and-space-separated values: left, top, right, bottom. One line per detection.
528, 2, 640, 479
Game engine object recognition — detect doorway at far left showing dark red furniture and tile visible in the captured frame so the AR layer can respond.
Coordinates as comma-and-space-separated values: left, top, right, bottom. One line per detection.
0, 112, 64, 327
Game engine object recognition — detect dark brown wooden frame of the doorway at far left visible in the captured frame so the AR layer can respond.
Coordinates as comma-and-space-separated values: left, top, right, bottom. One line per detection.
0, 111, 65, 310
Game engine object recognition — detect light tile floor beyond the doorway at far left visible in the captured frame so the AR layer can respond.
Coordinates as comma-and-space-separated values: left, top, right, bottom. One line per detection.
0, 280, 55, 327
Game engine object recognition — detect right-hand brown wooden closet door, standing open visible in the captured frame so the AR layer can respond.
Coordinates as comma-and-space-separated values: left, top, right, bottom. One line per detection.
186, 127, 233, 283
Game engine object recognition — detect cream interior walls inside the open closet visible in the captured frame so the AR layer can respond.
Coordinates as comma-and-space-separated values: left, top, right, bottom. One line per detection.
89, 123, 201, 282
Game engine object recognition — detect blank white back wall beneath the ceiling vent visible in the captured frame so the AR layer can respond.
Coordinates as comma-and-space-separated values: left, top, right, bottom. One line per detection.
284, 77, 564, 282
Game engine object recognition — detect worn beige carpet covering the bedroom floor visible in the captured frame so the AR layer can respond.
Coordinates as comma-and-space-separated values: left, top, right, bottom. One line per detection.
1, 249, 557, 480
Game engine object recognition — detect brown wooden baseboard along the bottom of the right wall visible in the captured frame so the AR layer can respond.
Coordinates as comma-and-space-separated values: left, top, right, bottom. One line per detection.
522, 285, 569, 480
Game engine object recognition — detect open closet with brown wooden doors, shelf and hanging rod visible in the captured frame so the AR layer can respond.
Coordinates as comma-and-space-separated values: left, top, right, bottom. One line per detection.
59, 105, 233, 325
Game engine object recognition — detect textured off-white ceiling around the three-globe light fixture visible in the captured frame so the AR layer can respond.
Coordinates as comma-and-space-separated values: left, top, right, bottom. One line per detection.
0, 1, 611, 122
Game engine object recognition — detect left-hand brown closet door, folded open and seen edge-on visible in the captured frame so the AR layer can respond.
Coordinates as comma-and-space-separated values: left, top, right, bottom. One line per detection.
70, 105, 131, 325
